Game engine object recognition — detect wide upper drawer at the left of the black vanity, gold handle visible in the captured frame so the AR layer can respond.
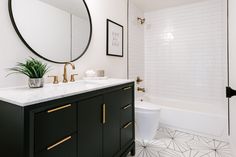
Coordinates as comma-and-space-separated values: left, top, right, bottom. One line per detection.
34, 104, 77, 152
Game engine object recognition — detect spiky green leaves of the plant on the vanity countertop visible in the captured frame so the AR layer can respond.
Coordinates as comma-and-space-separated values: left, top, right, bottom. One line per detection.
7, 57, 49, 78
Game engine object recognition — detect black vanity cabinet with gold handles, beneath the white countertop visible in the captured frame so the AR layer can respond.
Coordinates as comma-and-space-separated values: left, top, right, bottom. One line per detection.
0, 83, 135, 157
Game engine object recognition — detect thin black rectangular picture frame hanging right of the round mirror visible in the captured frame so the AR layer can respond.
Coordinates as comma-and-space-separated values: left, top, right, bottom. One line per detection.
106, 19, 124, 57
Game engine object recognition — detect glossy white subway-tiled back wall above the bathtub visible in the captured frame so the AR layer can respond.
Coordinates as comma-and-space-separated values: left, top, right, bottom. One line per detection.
144, 0, 227, 115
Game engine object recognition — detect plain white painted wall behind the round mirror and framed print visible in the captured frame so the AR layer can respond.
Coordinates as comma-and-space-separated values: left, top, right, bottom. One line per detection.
0, 0, 127, 87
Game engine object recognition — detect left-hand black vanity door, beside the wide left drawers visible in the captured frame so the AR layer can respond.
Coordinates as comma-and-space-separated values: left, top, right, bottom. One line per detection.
78, 96, 103, 157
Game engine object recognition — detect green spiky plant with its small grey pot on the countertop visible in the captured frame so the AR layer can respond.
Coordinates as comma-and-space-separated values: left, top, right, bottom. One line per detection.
8, 57, 49, 88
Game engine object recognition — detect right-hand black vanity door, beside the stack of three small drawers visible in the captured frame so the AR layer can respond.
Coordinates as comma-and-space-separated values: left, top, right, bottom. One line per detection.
103, 90, 122, 157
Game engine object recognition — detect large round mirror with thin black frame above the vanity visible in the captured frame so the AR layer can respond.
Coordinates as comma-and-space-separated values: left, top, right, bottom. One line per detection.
9, 0, 92, 63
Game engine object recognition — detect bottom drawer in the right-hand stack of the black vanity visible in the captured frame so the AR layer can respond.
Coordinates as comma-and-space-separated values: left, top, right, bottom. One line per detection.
121, 122, 134, 148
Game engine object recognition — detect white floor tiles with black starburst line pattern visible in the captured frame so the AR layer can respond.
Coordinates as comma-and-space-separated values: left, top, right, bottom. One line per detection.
128, 128, 232, 157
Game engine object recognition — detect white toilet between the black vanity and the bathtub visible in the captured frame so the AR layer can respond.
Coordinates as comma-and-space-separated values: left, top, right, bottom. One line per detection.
135, 101, 161, 141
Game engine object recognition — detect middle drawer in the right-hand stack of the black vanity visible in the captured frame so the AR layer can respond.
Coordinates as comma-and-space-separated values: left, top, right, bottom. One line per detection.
121, 104, 134, 126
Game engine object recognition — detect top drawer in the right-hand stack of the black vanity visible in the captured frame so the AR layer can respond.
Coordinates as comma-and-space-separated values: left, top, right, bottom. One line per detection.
121, 86, 133, 107
